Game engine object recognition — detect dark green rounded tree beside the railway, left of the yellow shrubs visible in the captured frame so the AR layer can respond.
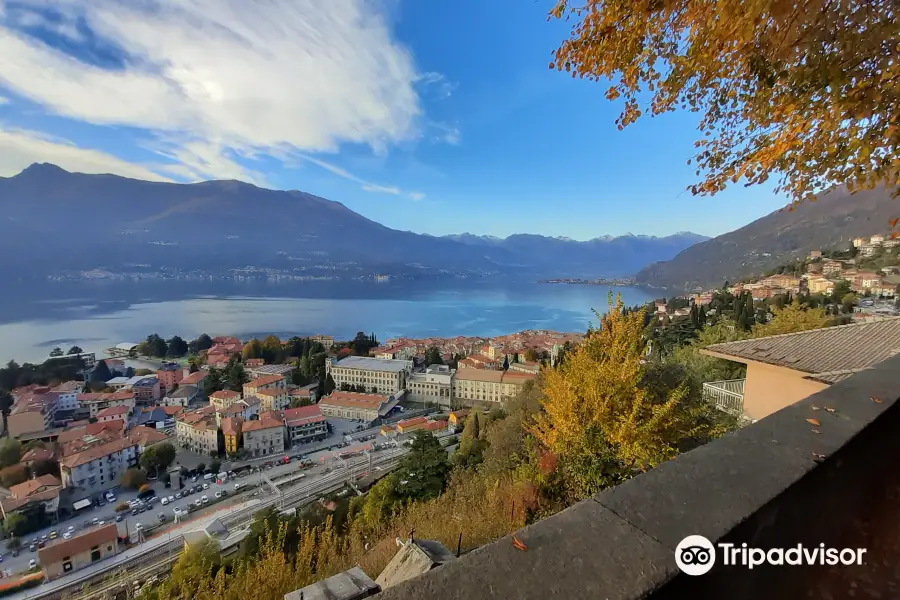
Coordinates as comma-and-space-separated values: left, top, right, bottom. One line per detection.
395, 430, 450, 501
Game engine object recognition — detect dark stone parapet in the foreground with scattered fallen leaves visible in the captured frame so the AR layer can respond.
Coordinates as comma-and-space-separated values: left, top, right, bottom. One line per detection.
378, 356, 900, 600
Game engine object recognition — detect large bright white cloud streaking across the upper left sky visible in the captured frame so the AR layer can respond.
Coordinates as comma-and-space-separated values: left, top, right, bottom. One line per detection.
0, 0, 436, 184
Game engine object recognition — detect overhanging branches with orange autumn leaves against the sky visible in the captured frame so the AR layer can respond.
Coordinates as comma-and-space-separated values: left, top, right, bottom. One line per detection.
550, 0, 900, 205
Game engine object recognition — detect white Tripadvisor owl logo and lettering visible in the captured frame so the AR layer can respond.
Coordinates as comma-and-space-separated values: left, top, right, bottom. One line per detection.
675, 535, 866, 575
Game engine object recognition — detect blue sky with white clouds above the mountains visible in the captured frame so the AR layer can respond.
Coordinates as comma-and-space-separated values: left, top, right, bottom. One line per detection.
0, 0, 785, 239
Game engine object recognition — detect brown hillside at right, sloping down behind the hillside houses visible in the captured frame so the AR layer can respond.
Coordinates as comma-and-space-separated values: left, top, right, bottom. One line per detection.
635, 187, 900, 290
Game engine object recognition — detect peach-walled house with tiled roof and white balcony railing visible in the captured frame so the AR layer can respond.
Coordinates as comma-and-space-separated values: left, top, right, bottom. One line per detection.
701, 317, 900, 421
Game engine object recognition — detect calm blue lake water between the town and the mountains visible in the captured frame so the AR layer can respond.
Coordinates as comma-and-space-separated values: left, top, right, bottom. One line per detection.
0, 281, 652, 364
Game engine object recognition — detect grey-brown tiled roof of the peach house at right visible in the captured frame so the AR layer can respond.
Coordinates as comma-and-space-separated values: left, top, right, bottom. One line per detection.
704, 317, 900, 383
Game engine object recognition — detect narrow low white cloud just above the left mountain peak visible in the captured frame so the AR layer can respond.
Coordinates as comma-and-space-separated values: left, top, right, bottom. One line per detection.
0, 124, 171, 181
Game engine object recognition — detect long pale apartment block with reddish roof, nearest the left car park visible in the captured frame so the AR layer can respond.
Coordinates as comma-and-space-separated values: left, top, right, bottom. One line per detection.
59, 438, 138, 498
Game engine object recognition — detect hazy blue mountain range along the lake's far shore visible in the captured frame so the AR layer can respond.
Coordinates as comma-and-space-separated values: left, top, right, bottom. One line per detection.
0, 164, 706, 279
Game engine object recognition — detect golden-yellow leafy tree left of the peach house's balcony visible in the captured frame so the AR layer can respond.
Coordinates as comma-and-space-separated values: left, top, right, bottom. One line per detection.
532, 296, 702, 496
